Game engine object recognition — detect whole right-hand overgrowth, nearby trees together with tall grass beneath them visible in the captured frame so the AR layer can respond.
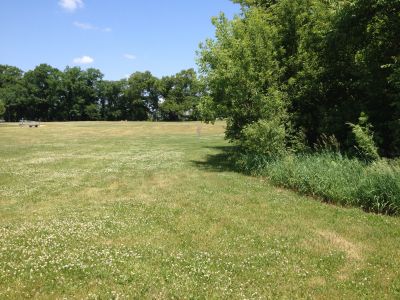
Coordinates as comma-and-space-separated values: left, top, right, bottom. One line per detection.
199, 0, 400, 214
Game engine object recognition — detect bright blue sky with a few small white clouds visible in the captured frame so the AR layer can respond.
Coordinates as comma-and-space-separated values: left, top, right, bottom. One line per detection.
0, 0, 240, 80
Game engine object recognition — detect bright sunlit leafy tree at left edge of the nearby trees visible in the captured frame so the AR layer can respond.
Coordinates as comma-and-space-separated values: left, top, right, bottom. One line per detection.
199, 8, 287, 140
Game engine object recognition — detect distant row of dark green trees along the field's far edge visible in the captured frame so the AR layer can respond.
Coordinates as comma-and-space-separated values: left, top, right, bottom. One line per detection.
0, 64, 201, 121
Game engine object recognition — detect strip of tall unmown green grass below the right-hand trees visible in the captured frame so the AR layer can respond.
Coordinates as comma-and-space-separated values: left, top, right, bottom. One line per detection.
237, 152, 400, 215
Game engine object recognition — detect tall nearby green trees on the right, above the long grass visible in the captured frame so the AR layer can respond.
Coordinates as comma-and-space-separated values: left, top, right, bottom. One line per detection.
198, 0, 400, 157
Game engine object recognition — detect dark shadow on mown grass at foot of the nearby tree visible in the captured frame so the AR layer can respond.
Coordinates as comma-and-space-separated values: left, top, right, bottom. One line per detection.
191, 146, 238, 172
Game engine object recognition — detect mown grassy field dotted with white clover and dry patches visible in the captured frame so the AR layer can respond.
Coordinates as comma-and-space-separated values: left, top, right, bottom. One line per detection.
0, 122, 400, 299
